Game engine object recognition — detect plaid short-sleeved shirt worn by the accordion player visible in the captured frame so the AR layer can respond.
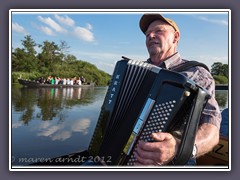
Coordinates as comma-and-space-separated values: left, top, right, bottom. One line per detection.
147, 53, 221, 129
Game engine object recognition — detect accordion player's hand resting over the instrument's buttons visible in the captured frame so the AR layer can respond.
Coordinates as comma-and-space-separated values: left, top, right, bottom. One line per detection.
134, 132, 178, 166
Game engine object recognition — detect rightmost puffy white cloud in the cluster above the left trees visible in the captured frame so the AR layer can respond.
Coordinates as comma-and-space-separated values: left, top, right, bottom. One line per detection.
73, 27, 94, 42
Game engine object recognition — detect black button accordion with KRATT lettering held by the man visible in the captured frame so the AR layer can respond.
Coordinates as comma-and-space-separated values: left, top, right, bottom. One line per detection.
88, 59, 210, 166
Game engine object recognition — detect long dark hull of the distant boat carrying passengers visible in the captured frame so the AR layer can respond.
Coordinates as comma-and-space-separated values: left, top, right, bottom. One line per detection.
18, 79, 94, 88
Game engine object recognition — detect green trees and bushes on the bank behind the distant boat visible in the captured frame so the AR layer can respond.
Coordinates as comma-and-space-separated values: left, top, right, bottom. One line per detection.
12, 35, 111, 85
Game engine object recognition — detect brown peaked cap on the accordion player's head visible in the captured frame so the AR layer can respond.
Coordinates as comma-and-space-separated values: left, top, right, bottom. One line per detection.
139, 14, 180, 34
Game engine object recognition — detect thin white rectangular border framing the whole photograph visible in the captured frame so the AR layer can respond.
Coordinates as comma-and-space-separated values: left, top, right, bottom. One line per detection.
9, 9, 231, 171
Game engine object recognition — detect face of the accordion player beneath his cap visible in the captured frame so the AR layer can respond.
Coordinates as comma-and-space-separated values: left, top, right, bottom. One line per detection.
145, 20, 176, 58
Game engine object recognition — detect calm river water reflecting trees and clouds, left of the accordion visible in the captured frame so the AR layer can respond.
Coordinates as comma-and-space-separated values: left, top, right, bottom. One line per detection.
12, 87, 107, 165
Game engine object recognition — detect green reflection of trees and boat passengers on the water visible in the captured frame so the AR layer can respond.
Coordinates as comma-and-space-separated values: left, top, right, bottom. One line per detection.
12, 88, 94, 124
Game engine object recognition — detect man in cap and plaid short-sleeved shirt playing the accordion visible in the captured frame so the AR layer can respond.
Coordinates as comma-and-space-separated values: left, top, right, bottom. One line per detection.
135, 14, 221, 165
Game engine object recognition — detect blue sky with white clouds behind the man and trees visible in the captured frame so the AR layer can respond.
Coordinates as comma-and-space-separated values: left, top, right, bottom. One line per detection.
9, 9, 231, 74
